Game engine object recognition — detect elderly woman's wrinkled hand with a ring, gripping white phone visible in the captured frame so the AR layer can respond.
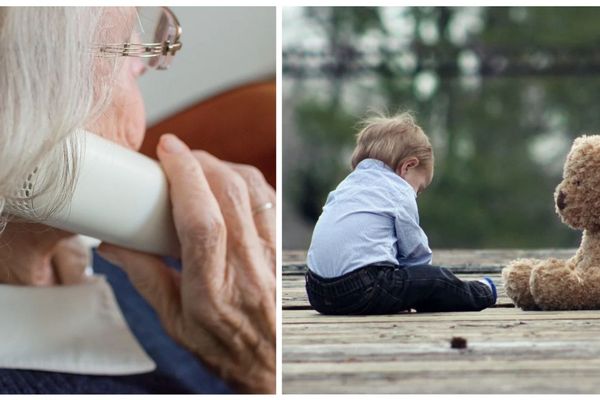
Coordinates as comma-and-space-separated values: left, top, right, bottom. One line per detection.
99, 135, 276, 393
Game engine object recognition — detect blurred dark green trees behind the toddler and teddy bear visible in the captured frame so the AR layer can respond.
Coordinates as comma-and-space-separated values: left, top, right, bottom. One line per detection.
284, 7, 600, 248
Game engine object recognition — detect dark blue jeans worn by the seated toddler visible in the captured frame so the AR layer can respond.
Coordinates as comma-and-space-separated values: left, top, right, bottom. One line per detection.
306, 263, 495, 315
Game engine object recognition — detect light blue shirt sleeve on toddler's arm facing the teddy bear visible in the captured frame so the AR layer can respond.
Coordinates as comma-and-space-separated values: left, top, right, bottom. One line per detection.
394, 205, 431, 265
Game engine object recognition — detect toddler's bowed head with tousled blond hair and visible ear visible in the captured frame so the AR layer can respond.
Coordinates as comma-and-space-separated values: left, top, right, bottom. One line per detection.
352, 112, 433, 193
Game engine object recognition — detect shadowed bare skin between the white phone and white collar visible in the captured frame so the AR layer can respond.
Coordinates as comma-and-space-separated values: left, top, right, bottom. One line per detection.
0, 222, 90, 286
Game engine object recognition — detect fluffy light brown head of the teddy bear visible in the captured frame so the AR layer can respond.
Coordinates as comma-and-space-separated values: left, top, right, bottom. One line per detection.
554, 135, 600, 232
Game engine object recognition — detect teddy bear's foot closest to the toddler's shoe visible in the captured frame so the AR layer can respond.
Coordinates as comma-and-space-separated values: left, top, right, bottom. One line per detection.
502, 258, 541, 310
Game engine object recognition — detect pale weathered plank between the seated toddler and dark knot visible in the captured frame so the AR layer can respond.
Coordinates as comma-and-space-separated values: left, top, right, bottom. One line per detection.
283, 319, 600, 346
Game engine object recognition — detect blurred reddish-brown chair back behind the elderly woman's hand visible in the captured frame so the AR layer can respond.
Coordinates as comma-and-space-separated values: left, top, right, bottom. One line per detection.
141, 80, 276, 187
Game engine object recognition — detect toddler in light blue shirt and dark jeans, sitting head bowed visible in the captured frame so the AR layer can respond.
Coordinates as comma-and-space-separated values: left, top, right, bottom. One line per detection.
306, 113, 496, 314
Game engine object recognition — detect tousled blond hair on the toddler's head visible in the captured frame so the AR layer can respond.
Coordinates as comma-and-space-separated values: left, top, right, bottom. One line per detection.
352, 112, 433, 170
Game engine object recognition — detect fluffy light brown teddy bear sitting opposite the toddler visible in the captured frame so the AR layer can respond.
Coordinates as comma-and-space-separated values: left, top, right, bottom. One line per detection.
502, 135, 600, 310
